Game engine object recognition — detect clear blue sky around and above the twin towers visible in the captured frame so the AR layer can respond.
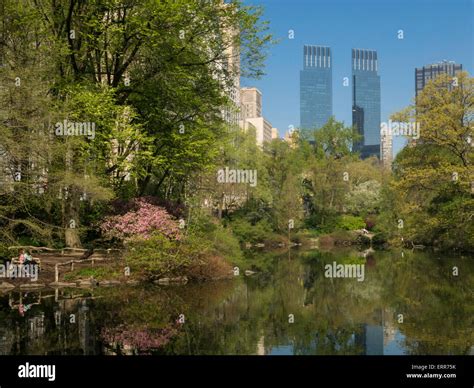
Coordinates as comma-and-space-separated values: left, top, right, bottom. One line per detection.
242, 0, 474, 155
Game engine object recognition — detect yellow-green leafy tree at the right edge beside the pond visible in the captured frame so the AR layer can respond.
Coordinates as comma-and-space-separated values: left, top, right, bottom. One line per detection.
380, 73, 474, 251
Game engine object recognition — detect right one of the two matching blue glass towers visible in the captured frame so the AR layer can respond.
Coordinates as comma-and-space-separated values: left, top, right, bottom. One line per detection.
352, 49, 381, 159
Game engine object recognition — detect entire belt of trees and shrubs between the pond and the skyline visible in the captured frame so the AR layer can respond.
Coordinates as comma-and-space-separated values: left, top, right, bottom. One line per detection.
0, 0, 474, 292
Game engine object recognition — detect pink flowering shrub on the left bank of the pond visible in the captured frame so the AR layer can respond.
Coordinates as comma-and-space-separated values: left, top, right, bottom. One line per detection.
100, 198, 180, 241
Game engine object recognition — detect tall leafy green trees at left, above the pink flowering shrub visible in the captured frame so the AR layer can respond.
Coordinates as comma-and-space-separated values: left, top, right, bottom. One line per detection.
0, 0, 273, 250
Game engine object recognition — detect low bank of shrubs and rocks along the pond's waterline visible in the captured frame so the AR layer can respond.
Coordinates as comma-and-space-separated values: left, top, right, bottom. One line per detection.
0, 223, 466, 292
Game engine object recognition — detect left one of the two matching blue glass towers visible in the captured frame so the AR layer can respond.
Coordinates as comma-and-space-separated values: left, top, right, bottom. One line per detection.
300, 45, 332, 130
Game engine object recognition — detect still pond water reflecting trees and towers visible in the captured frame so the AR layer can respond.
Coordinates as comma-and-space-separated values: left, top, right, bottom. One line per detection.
0, 250, 474, 355
